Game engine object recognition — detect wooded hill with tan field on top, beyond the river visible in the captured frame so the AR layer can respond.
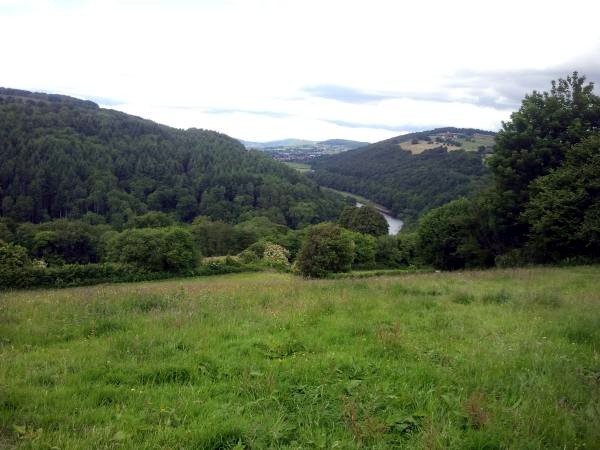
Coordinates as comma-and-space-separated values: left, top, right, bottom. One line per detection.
311, 128, 494, 219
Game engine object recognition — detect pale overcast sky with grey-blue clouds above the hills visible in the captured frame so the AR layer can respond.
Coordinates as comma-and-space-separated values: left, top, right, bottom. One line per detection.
0, 0, 600, 142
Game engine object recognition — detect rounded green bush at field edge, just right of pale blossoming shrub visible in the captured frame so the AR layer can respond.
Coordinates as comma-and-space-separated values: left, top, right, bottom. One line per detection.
296, 223, 354, 278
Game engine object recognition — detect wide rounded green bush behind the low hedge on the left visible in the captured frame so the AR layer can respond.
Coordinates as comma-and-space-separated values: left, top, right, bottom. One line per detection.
107, 227, 199, 272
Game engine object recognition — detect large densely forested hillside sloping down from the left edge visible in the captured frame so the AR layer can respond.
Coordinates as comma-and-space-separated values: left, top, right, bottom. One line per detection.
0, 88, 342, 226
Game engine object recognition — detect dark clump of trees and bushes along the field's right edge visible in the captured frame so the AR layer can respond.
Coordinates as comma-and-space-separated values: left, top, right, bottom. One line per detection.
418, 72, 600, 269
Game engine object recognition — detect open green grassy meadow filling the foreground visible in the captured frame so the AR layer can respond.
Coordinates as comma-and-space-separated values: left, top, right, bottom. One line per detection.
0, 267, 600, 449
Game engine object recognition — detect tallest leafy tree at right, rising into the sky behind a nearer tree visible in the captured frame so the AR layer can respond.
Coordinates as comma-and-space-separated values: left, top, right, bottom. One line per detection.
489, 72, 600, 249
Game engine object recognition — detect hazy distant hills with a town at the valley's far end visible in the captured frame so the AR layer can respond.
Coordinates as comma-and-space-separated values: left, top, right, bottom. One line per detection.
241, 139, 368, 162
